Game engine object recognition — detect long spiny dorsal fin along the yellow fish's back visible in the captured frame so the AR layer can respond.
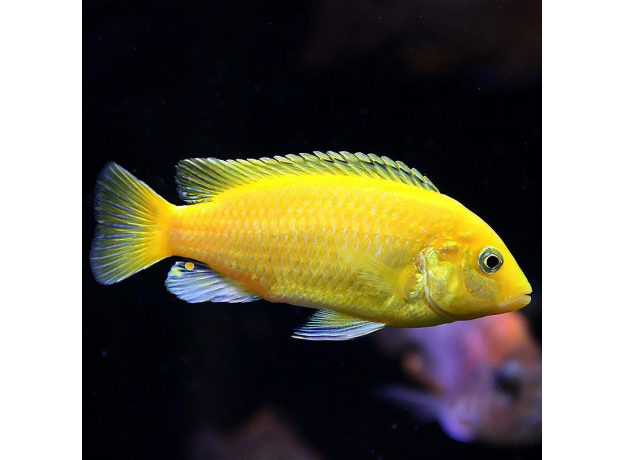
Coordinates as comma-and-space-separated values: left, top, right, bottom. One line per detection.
176, 152, 438, 204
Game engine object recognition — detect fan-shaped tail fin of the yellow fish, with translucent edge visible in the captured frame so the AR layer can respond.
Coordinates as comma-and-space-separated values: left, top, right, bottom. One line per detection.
91, 163, 174, 284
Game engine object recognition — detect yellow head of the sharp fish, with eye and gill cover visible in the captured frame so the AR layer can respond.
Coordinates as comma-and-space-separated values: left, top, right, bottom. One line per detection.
421, 216, 531, 321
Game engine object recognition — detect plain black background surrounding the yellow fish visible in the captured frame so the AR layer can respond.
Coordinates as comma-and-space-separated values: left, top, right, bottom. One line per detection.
83, 0, 541, 459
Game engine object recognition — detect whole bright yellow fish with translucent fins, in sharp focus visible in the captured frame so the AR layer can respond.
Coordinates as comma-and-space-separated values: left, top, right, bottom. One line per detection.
91, 152, 531, 340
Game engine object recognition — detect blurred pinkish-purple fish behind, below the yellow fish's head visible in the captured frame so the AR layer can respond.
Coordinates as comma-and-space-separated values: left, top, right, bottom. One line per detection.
375, 312, 542, 445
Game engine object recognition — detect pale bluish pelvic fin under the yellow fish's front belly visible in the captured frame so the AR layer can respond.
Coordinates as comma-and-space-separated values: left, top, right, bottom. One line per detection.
293, 310, 385, 340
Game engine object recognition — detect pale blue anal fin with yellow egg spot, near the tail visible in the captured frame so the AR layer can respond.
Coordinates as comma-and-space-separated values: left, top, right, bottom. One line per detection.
165, 262, 259, 303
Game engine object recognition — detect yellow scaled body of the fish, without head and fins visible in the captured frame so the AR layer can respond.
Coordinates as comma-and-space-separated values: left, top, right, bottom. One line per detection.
170, 176, 431, 318
